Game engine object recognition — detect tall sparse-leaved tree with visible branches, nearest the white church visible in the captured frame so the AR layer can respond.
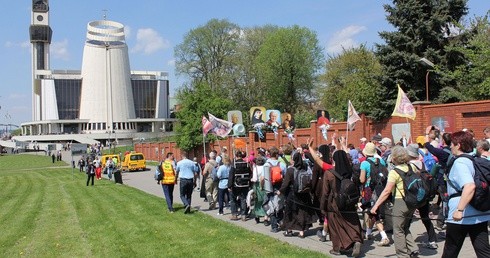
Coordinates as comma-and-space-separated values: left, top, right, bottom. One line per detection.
174, 19, 241, 92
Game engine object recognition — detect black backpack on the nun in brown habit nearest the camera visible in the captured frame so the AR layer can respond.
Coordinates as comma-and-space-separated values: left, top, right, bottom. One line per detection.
329, 170, 361, 211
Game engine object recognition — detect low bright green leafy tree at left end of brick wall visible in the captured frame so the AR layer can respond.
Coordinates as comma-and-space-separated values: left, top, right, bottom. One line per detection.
175, 83, 232, 150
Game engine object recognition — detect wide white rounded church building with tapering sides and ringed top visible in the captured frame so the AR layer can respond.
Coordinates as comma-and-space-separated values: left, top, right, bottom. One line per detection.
80, 20, 136, 132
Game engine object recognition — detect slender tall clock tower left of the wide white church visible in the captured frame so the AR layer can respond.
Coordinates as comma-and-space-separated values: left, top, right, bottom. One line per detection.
29, 0, 53, 121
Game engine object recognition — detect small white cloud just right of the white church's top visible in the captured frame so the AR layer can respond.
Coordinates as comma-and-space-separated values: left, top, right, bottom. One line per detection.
132, 28, 170, 55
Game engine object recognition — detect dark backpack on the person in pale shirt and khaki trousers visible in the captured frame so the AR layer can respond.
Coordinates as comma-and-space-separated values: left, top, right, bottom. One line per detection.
394, 164, 432, 208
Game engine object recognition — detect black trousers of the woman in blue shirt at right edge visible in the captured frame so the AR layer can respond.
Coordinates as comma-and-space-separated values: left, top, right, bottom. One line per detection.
442, 222, 490, 258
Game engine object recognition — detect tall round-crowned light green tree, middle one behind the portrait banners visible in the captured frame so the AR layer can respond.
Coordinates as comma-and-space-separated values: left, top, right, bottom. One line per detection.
255, 26, 324, 113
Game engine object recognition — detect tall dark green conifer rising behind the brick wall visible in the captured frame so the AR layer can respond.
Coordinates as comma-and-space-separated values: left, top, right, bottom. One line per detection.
376, 0, 467, 116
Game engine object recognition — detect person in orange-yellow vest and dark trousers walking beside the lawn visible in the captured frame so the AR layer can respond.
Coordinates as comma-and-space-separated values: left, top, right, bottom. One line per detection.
160, 152, 177, 213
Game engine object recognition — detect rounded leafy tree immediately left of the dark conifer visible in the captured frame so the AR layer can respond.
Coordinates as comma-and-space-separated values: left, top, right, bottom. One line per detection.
320, 45, 386, 121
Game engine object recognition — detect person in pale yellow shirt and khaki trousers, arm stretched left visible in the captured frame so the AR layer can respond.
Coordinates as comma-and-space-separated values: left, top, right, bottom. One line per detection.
374, 146, 419, 257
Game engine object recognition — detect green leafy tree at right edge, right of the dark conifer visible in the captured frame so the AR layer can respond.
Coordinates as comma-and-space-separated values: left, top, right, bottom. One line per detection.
438, 15, 490, 102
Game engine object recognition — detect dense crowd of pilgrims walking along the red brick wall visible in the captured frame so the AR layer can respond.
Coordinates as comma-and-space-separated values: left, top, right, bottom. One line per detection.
194, 128, 490, 257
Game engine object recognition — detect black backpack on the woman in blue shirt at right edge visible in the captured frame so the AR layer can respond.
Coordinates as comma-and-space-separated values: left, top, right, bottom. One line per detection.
447, 154, 490, 211
